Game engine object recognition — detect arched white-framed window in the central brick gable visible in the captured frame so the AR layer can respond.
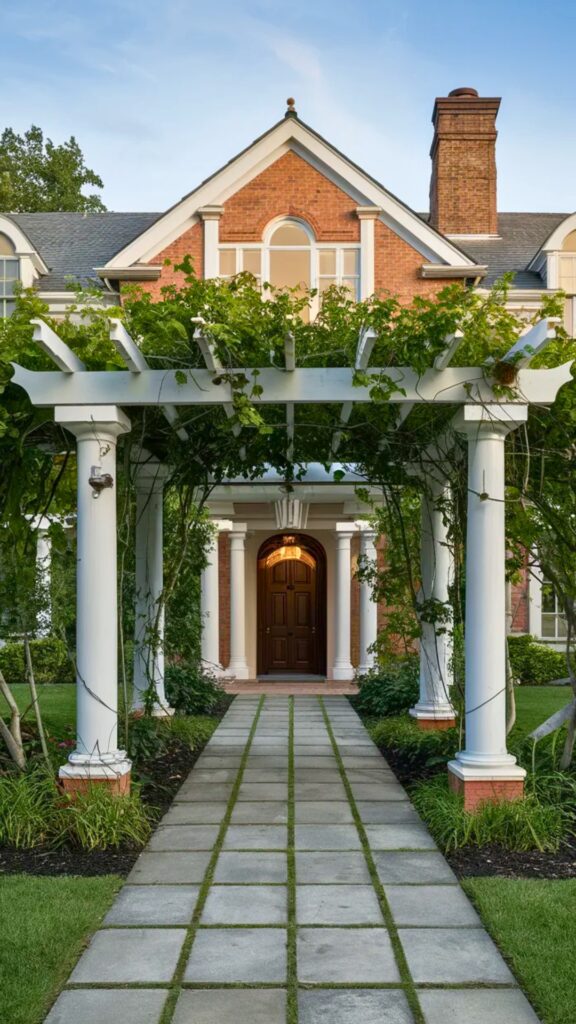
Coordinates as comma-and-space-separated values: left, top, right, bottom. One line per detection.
218, 218, 360, 299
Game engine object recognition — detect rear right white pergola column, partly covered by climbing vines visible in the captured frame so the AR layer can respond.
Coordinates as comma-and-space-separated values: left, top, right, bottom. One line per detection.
410, 479, 456, 729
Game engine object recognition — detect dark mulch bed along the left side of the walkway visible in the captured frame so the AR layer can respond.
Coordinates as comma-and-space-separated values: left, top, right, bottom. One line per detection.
0, 708, 225, 877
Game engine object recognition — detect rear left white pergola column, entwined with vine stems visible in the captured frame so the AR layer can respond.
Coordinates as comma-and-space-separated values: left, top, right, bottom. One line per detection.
132, 459, 173, 718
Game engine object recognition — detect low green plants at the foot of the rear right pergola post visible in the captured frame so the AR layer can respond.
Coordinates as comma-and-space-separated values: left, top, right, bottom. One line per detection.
369, 717, 460, 778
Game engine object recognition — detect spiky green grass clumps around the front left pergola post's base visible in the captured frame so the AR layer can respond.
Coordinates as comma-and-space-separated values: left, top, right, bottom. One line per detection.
0, 768, 151, 850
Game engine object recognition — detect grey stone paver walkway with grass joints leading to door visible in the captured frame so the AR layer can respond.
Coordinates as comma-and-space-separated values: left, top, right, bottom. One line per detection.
46, 696, 538, 1024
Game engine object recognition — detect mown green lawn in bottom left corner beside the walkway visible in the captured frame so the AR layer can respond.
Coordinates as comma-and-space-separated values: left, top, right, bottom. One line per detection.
0, 874, 122, 1024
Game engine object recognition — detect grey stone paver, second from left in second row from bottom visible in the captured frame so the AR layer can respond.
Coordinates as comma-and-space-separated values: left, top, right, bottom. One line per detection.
184, 928, 286, 983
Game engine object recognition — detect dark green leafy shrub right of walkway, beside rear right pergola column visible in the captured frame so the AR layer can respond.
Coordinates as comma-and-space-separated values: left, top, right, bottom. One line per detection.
351, 656, 420, 718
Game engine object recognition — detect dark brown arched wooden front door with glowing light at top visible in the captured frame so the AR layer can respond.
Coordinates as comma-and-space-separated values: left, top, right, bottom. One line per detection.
258, 534, 326, 676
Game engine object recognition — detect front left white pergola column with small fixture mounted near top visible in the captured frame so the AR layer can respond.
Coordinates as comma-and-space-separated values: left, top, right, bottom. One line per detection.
55, 406, 131, 793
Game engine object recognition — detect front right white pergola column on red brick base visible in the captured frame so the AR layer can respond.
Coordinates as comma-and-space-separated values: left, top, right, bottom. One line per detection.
448, 404, 528, 809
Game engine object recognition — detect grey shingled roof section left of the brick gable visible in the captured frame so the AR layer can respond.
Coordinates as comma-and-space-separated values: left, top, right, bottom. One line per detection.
9, 213, 161, 292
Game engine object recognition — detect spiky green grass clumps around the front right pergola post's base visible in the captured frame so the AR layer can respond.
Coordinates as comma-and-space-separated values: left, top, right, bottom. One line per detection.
412, 776, 573, 853
